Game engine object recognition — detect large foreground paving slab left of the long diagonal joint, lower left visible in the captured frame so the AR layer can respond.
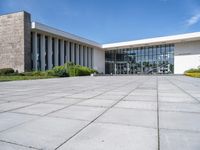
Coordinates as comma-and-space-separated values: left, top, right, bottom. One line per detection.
0, 117, 87, 149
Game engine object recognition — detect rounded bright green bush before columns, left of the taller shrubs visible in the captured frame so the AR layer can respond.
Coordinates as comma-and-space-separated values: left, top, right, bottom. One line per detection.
51, 66, 69, 77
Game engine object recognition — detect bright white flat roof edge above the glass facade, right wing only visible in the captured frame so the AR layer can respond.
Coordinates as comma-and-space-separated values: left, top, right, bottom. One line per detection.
102, 32, 200, 49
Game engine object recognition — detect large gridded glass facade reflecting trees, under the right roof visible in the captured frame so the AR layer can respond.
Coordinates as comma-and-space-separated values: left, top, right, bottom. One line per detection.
105, 44, 174, 74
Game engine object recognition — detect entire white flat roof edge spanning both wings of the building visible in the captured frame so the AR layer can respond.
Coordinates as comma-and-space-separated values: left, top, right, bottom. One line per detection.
32, 22, 200, 50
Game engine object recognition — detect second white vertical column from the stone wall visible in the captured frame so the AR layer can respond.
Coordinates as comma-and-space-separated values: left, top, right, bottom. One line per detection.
40, 34, 46, 71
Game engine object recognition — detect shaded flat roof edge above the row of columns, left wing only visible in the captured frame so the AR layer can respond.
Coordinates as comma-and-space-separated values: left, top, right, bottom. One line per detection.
31, 22, 102, 48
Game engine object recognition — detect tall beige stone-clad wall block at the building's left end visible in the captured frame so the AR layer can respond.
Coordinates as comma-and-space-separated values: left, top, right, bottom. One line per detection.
0, 12, 31, 72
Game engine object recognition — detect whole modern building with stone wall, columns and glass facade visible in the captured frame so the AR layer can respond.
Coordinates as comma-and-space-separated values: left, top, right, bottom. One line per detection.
0, 11, 200, 74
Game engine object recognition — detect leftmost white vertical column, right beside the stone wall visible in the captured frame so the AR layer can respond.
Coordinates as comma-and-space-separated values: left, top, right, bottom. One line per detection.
32, 32, 38, 71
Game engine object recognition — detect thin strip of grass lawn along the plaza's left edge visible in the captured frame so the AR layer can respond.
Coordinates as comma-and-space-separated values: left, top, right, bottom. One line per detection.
0, 75, 56, 82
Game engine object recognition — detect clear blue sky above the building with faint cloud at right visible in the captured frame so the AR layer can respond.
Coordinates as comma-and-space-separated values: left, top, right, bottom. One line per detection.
0, 0, 200, 43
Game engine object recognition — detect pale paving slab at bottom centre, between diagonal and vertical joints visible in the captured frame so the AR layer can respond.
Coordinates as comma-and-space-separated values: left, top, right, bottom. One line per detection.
58, 123, 158, 150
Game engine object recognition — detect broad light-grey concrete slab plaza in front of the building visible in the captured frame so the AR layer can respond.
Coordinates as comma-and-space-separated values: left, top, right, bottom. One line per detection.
0, 76, 200, 150
